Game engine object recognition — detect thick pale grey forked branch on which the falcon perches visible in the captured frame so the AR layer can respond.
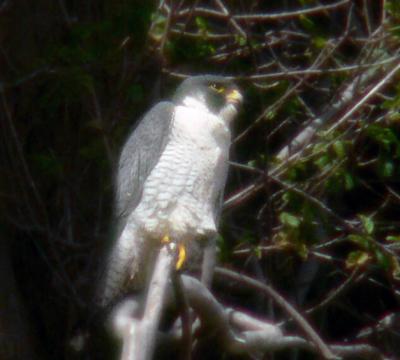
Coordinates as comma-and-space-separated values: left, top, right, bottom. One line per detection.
114, 272, 384, 360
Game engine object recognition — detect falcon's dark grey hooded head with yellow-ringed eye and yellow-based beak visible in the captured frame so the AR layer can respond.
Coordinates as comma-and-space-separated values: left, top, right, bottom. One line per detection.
174, 75, 243, 116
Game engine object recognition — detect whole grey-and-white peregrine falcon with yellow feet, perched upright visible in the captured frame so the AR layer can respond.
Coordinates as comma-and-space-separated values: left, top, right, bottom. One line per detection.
101, 75, 242, 304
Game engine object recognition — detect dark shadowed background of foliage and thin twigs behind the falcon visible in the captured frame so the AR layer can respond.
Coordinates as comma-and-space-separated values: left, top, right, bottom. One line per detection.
0, 0, 400, 359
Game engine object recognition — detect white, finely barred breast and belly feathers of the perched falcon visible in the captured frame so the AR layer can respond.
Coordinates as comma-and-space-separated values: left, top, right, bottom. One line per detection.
132, 102, 230, 242
